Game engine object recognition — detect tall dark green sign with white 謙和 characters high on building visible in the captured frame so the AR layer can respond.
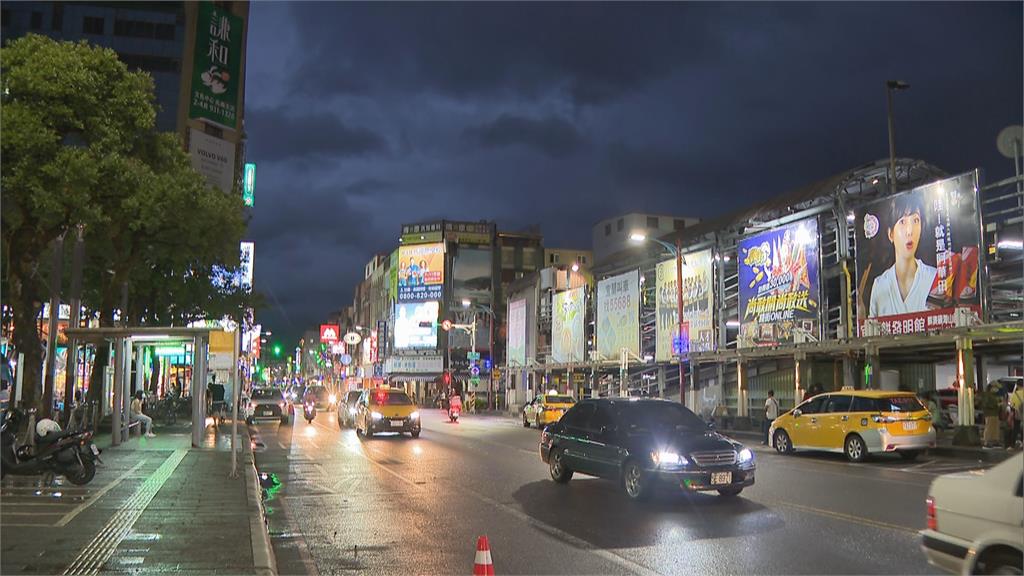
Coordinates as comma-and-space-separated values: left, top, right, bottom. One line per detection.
188, 2, 244, 130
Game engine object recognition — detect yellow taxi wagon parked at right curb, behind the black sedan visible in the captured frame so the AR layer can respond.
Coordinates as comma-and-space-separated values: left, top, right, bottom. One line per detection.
768, 388, 935, 462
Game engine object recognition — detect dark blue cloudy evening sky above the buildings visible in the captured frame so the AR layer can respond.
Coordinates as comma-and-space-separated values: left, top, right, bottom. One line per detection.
246, 2, 1024, 338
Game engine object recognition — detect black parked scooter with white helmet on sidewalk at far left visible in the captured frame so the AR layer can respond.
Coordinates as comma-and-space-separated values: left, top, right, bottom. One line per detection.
0, 411, 101, 486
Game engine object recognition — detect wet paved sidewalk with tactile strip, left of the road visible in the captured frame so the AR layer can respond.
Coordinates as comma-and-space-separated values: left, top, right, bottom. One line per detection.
0, 424, 275, 574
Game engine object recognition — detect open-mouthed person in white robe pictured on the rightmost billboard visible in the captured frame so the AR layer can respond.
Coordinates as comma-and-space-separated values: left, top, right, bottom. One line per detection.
865, 194, 936, 318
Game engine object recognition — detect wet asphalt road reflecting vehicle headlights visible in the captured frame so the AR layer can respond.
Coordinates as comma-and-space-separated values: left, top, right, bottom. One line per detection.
253, 410, 980, 574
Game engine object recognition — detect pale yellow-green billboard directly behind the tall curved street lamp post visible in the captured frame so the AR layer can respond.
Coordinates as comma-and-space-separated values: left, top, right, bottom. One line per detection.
654, 250, 715, 362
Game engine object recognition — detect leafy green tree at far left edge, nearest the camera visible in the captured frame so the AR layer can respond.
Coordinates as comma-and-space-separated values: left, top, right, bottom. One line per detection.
0, 35, 156, 406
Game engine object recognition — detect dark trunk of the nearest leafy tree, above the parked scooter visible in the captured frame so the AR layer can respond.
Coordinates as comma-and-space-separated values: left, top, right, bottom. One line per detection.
9, 260, 43, 410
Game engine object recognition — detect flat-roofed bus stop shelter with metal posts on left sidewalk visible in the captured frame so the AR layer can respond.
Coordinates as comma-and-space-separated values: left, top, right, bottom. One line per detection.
67, 326, 216, 447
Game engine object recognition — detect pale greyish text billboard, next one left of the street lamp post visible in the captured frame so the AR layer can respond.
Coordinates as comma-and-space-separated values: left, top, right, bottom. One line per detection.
597, 270, 640, 359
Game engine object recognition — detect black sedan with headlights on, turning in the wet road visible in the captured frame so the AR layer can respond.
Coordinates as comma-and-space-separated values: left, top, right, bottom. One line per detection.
541, 398, 755, 500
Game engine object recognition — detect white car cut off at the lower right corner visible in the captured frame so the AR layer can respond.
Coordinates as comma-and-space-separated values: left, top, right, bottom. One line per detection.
921, 454, 1024, 574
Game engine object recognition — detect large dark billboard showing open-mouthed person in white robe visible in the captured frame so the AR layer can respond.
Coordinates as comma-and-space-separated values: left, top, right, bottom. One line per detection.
855, 171, 981, 335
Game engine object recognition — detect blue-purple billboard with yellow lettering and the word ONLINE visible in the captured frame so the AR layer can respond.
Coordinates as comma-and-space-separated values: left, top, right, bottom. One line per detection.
737, 218, 821, 347
